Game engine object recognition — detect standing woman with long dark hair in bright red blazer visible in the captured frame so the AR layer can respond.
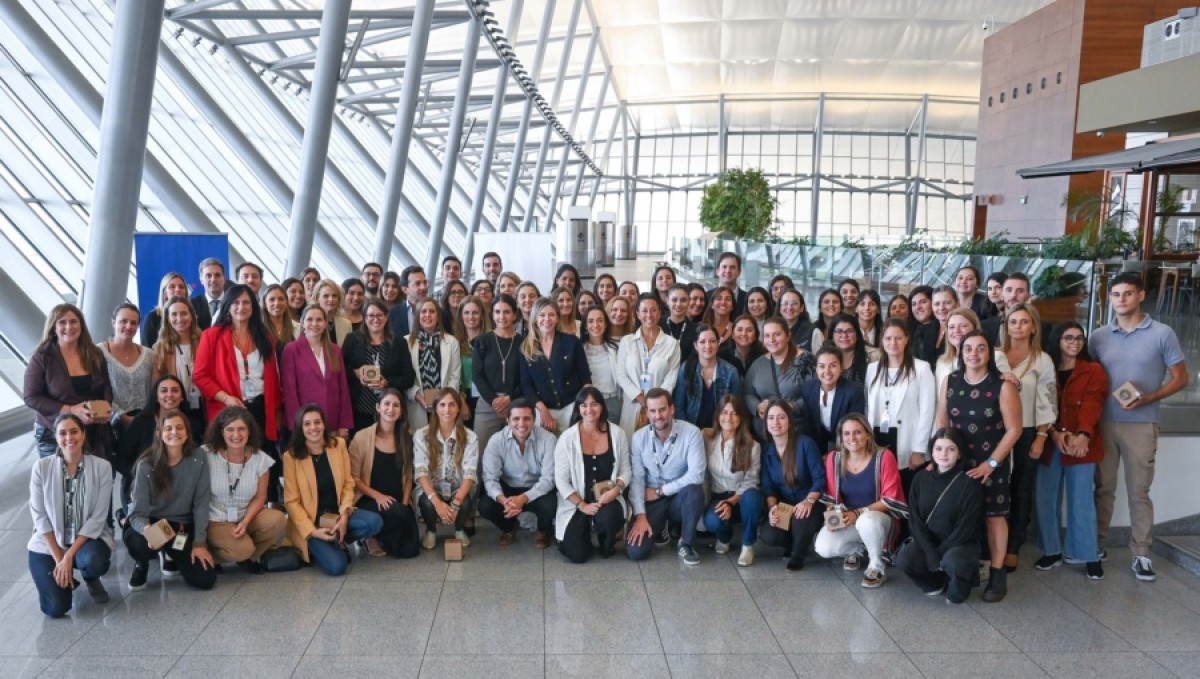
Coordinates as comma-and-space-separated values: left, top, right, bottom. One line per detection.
192, 284, 282, 443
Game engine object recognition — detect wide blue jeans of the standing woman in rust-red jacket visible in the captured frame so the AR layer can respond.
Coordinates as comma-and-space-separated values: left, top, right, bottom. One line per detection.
1037, 446, 1099, 561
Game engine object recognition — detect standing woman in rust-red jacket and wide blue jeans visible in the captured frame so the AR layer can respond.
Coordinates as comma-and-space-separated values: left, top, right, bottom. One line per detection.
1033, 323, 1109, 579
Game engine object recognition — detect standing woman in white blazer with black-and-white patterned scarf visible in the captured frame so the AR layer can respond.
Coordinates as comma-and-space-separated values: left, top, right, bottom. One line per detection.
404, 298, 458, 432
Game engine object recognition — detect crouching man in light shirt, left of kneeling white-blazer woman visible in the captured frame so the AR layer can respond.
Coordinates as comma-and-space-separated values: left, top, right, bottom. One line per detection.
479, 398, 558, 548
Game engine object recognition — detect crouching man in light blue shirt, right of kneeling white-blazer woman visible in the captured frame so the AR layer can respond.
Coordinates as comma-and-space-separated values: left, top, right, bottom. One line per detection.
625, 387, 708, 566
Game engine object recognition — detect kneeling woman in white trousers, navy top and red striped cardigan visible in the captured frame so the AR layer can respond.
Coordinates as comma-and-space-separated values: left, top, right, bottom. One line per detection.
816, 413, 904, 588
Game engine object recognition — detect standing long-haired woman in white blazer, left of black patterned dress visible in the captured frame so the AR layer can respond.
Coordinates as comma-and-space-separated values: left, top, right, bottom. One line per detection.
866, 319, 937, 470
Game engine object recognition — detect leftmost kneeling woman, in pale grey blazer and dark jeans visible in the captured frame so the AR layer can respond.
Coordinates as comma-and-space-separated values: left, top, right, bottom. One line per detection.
26, 413, 113, 618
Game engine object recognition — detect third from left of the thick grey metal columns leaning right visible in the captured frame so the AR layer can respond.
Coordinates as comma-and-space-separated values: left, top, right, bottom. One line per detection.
374, 0, 434, 262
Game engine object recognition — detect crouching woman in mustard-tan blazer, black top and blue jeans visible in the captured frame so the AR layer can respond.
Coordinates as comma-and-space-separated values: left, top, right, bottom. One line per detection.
283, 404, 383, 576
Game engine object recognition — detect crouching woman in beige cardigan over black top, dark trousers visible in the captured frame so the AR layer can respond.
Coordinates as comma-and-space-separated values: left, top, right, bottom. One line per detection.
350, 389, 421, 559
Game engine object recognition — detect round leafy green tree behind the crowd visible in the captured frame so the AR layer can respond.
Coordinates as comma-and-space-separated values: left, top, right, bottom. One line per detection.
700, 169, 779, 241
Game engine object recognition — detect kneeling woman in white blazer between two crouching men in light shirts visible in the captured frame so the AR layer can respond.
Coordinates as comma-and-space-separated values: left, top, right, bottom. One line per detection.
554, 386, 631, 564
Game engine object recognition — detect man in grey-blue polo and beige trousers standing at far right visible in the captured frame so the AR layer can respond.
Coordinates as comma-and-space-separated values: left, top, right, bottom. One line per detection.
1088, 274, 1188, 582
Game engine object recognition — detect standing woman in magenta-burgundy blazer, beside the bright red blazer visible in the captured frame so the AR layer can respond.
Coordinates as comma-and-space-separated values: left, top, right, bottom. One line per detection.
280, 306, 354, 439
